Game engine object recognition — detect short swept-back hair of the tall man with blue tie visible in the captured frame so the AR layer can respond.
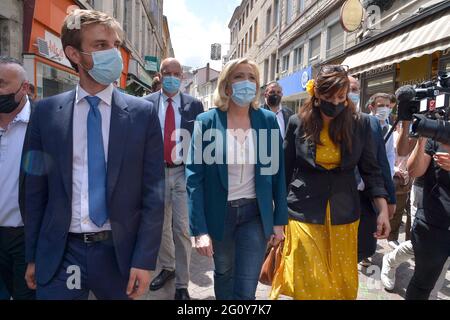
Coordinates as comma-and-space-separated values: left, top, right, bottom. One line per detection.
61, 9, 124, 71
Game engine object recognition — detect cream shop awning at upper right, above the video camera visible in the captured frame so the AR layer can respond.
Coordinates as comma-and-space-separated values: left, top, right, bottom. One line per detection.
342, 10, 450, 74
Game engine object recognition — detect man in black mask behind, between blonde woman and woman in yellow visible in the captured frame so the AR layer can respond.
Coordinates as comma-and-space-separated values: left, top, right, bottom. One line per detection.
263, 81, 294, 139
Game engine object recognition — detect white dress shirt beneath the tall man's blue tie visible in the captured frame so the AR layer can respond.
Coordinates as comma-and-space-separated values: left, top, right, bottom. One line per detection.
70, 84, 114, 233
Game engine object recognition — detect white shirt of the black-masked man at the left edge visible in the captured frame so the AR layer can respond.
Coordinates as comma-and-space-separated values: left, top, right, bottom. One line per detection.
0, 101, 31, 228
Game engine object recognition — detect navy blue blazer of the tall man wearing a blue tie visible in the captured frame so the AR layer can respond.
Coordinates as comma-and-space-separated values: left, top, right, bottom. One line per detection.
25, 89, 164, 284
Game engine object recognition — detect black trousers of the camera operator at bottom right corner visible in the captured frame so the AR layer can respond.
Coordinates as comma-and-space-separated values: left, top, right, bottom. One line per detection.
405, 218, 450, 300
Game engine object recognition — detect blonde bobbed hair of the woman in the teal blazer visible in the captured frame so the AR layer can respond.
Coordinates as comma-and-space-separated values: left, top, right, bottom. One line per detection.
214, 58, 260, 111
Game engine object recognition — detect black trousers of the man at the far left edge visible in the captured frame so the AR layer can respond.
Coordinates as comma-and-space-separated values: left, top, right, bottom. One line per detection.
0, 227, 35, 300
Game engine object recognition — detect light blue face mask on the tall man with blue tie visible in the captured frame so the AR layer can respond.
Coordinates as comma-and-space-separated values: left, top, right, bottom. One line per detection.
81, 48, 123, 86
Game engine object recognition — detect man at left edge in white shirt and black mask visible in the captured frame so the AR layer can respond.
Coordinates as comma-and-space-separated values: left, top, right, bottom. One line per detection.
0, 57, 35, 300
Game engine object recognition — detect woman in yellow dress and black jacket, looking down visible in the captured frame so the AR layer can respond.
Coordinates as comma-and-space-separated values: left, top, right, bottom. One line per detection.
270, 66, 390, 300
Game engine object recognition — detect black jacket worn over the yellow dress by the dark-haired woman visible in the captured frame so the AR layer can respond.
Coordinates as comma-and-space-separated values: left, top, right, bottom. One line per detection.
284, 115, 387, 225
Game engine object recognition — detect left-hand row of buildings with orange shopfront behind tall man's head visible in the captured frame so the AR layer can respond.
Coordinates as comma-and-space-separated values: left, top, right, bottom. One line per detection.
9, 0, 173, 98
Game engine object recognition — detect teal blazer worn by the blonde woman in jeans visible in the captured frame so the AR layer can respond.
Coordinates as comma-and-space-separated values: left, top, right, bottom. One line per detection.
186, 108, 288, 240
